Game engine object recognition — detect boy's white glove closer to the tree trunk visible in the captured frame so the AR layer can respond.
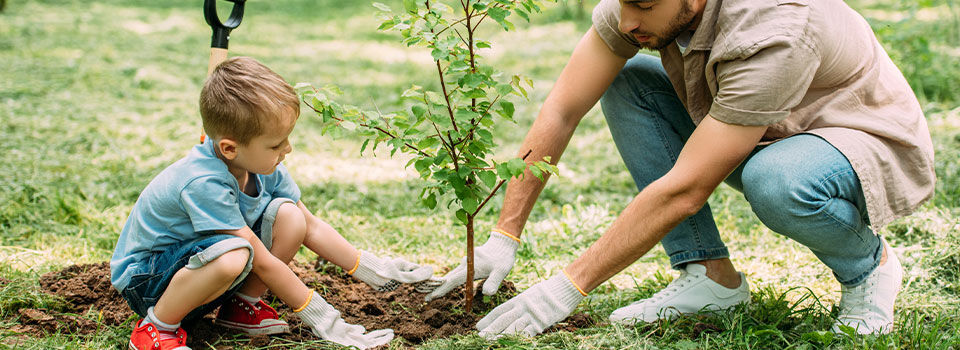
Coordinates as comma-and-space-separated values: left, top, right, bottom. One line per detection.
351, 250, 433, 292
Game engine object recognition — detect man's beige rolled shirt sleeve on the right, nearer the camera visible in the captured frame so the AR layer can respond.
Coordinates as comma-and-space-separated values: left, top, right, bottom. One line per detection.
710, 40, 820, 126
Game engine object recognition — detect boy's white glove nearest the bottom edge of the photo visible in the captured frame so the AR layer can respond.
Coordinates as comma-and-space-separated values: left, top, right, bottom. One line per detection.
296, 292, 393, 349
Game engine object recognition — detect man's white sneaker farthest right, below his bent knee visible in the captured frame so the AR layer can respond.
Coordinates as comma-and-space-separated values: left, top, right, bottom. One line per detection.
833, 238, 903, 334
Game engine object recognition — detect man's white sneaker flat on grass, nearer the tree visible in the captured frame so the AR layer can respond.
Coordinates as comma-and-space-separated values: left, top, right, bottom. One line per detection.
610, 263, 750, 324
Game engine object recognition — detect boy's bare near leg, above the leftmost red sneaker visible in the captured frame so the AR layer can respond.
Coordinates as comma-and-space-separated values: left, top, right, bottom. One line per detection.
153, 248, 250, 324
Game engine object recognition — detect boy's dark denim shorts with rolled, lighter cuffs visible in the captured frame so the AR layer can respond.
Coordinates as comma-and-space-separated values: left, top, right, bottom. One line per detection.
120, 198, 293, 320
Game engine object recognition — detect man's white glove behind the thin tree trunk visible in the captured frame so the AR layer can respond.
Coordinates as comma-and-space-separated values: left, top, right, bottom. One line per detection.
426, 230, 520, 301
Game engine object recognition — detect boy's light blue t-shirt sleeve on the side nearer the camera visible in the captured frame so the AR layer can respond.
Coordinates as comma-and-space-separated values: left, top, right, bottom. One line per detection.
180, 176, 247, 232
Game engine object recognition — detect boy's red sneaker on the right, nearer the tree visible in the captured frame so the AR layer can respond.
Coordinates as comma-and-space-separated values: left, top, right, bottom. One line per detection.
214, 295, 290, 335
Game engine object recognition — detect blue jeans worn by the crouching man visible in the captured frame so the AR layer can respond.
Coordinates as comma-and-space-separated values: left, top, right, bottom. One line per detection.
601, 54, 883, 286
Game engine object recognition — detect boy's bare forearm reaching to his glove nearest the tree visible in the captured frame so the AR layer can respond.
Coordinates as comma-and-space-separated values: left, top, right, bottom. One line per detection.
297, 202, 360, 270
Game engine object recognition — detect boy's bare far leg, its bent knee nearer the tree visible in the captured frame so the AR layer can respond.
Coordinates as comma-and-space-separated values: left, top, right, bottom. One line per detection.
237, 203, 307, 298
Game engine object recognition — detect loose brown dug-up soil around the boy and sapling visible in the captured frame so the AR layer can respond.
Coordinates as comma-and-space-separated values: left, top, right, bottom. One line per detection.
11, 262, 593, 350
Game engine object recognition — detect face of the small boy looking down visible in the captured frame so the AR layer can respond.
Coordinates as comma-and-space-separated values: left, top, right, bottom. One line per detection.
228, 113, 297, 175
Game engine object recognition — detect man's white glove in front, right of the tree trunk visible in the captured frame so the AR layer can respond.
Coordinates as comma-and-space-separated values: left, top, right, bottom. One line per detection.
477, 273, 584, 339
